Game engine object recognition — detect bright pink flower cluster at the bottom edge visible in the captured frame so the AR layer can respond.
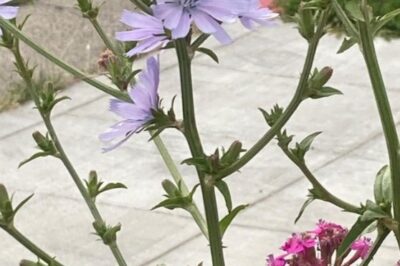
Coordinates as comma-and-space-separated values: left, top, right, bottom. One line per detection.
267, 220, 372, 266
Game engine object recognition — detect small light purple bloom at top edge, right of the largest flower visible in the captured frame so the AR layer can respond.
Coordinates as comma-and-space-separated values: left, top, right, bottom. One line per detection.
237, 0, 278, 30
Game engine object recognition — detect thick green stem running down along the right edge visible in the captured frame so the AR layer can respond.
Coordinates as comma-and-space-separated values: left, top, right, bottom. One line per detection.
358, 6, 400, 247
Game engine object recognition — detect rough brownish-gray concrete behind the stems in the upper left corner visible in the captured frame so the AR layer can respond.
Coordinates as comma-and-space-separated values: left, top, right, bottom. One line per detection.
0, 0, 134, 110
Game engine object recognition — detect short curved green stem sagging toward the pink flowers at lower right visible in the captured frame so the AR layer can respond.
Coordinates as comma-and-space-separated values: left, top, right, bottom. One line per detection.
282, 143, 362, 214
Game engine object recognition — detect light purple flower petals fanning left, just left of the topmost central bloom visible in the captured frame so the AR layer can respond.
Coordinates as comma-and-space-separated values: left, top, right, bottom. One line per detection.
116, 10, 169, 56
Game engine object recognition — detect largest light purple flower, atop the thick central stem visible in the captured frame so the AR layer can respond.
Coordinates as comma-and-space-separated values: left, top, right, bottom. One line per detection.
153, 0, 237, 44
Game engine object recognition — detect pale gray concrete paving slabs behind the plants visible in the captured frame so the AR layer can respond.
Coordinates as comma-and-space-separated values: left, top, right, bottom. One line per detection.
0, 19, 400, 266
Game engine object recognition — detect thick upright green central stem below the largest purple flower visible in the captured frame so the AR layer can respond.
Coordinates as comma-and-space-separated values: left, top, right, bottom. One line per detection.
175, 39, 225, 266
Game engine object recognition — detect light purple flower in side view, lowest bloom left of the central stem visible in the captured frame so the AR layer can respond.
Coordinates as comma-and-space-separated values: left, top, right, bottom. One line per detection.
100, 57, 160, 152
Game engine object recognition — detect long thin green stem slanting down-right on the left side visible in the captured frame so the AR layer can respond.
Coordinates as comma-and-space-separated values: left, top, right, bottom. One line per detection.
12, 42, 127, 266
